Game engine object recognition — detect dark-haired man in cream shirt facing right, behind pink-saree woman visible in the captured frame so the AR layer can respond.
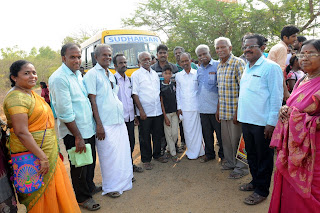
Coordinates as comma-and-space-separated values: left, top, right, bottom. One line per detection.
268, 25, 300, 101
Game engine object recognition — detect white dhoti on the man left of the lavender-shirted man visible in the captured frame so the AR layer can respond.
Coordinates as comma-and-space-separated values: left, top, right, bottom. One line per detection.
96, 123, 133, 195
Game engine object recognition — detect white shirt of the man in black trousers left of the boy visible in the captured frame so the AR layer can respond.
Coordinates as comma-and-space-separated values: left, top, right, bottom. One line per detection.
131, 67, 162, 117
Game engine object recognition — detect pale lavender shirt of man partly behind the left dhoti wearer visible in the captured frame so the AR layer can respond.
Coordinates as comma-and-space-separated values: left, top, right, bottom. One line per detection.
114, 72, 134, 122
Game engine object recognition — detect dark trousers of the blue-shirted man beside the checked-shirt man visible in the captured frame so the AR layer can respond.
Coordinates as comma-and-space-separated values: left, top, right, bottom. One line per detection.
200, 113, 223, 159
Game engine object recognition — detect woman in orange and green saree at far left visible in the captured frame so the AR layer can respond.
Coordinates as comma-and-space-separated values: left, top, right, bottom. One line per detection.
3, 60, 80, 213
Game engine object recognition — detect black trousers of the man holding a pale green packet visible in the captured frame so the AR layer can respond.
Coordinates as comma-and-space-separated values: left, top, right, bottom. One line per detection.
63, 135, 96, 203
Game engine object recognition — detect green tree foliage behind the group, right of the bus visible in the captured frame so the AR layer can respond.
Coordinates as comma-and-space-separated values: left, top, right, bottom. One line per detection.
122, 0, 320, 56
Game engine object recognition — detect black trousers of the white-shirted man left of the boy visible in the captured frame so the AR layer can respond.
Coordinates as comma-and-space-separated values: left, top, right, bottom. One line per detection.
139, 115, 163, 163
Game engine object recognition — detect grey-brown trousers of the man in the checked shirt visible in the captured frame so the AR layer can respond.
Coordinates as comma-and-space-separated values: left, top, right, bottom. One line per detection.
221, 120, 248, 174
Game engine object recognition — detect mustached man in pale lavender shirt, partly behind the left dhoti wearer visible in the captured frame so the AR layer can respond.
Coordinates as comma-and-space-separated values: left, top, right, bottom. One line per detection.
113, 54, 143, 172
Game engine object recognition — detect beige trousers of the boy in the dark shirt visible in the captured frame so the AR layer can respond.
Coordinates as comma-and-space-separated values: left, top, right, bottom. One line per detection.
163, 112, 179, 156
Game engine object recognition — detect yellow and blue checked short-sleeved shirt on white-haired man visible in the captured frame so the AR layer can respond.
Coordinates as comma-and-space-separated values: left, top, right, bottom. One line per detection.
217, 54, 246, 120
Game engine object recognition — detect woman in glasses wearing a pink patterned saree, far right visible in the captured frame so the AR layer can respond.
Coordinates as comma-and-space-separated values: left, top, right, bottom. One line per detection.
269, 39, 320, 213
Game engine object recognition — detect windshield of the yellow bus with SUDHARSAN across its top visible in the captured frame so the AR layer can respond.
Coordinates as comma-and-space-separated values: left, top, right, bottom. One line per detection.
104, 35, 161, 69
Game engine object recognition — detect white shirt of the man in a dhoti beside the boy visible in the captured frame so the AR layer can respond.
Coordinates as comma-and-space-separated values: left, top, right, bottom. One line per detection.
176, 69, 198, 111
